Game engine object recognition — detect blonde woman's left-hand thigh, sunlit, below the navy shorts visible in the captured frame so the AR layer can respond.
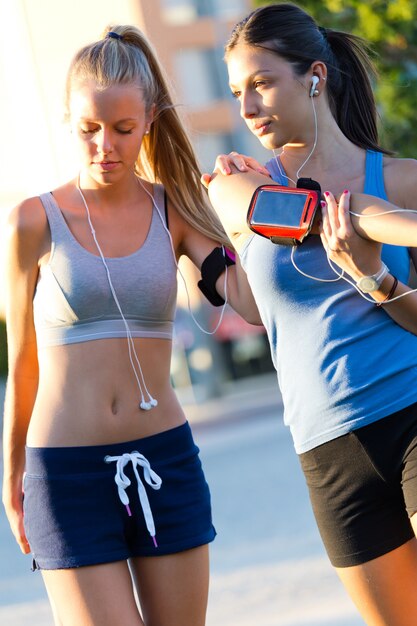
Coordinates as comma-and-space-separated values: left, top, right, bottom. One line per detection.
42, 561, 144, 626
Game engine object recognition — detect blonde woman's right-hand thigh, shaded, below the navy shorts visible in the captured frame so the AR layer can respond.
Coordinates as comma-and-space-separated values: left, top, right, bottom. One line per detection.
129, 545, 209, 626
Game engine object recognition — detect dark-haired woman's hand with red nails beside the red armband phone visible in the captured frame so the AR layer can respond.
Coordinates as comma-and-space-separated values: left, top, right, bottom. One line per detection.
320, 191, 382, 282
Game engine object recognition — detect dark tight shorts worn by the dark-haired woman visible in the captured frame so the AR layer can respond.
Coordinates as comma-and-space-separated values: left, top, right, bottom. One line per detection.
300, 404, 417, 567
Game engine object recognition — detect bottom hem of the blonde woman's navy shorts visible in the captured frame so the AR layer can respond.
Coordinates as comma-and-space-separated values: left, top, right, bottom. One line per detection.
33, 527, 217, 570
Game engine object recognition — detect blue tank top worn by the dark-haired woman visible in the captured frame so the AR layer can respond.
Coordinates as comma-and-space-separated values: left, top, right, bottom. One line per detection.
240, 151, 417, 453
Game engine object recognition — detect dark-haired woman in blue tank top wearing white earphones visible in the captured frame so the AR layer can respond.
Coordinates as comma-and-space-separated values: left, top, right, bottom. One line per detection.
203, 4, 417, 626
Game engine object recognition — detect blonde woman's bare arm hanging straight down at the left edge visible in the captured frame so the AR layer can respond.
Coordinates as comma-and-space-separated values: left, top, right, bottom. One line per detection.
3, 199, 46, 553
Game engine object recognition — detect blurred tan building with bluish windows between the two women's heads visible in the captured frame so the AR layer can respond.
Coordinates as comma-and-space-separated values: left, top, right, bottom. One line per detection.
138, 0, 267, 170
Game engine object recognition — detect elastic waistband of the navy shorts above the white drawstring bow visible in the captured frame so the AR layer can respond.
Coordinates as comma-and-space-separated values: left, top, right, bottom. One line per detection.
26, 422, 195, 475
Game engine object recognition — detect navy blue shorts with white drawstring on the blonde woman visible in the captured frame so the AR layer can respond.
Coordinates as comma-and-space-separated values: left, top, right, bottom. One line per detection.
24, 423, 216, 569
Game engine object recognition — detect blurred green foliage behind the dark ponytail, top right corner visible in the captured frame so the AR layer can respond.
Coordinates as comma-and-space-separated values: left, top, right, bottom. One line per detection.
253, 0, 417, 158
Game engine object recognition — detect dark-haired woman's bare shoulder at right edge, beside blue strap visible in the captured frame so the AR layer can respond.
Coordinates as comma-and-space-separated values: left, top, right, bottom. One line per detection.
384, 156, 417, 206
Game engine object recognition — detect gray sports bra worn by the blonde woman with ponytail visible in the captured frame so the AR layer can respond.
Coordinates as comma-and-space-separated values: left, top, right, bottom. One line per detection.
33, 185, 177, 348
